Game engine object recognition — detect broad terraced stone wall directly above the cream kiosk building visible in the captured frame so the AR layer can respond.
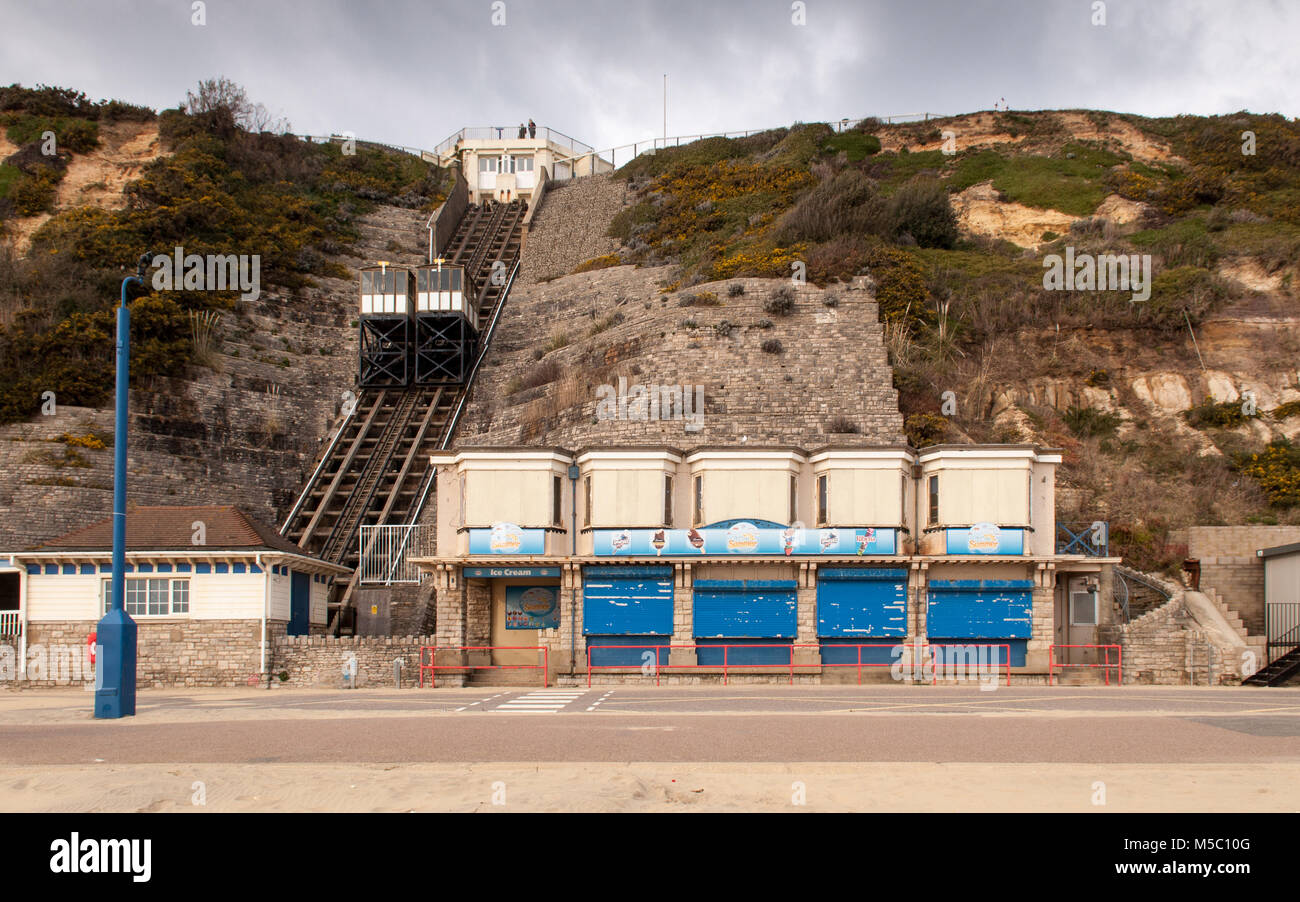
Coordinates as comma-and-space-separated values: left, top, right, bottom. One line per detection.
456, 266, 904, 448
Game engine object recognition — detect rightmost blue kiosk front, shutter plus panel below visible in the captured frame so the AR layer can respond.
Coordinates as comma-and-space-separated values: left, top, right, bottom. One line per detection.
926, 580, 1034, 667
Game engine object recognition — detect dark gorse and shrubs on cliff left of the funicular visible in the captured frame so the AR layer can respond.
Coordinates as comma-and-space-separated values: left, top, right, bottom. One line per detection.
0, 80, 443, 422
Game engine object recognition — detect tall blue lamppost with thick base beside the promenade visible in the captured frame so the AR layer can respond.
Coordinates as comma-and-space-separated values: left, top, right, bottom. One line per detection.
95, 253, 150, 717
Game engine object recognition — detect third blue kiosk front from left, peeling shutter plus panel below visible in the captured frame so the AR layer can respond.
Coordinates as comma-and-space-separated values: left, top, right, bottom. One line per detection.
816, 567, 907, 664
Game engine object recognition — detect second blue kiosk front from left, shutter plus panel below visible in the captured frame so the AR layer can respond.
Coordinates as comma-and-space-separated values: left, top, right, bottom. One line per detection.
694, 580, 798, 667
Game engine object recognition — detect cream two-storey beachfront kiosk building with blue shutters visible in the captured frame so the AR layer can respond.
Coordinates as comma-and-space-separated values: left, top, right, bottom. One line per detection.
416, 445, 1115, 682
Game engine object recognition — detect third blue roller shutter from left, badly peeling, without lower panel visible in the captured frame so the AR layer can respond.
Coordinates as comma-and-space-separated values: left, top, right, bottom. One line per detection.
816, 567, 907, 641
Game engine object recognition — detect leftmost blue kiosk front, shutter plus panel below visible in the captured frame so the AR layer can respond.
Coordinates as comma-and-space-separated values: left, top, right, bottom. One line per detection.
582, 565, 672, 667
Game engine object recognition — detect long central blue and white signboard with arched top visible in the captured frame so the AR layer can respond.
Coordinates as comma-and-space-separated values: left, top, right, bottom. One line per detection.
594, 520, 896, 558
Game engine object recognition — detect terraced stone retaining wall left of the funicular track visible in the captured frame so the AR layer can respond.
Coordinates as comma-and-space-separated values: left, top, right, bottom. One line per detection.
0, 200, 426, 548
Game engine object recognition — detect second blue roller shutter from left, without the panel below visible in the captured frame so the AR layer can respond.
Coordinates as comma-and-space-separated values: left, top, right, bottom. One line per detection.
694, 580, 798, 639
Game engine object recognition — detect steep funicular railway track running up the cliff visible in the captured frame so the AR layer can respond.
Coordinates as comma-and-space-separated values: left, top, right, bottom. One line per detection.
281, 201, 527, 628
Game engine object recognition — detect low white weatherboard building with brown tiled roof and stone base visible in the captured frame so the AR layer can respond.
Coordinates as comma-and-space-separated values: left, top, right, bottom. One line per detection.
0, 506, 351, 686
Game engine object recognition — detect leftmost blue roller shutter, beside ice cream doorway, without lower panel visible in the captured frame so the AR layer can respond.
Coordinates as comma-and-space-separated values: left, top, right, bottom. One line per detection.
582, 567, 672, 636
